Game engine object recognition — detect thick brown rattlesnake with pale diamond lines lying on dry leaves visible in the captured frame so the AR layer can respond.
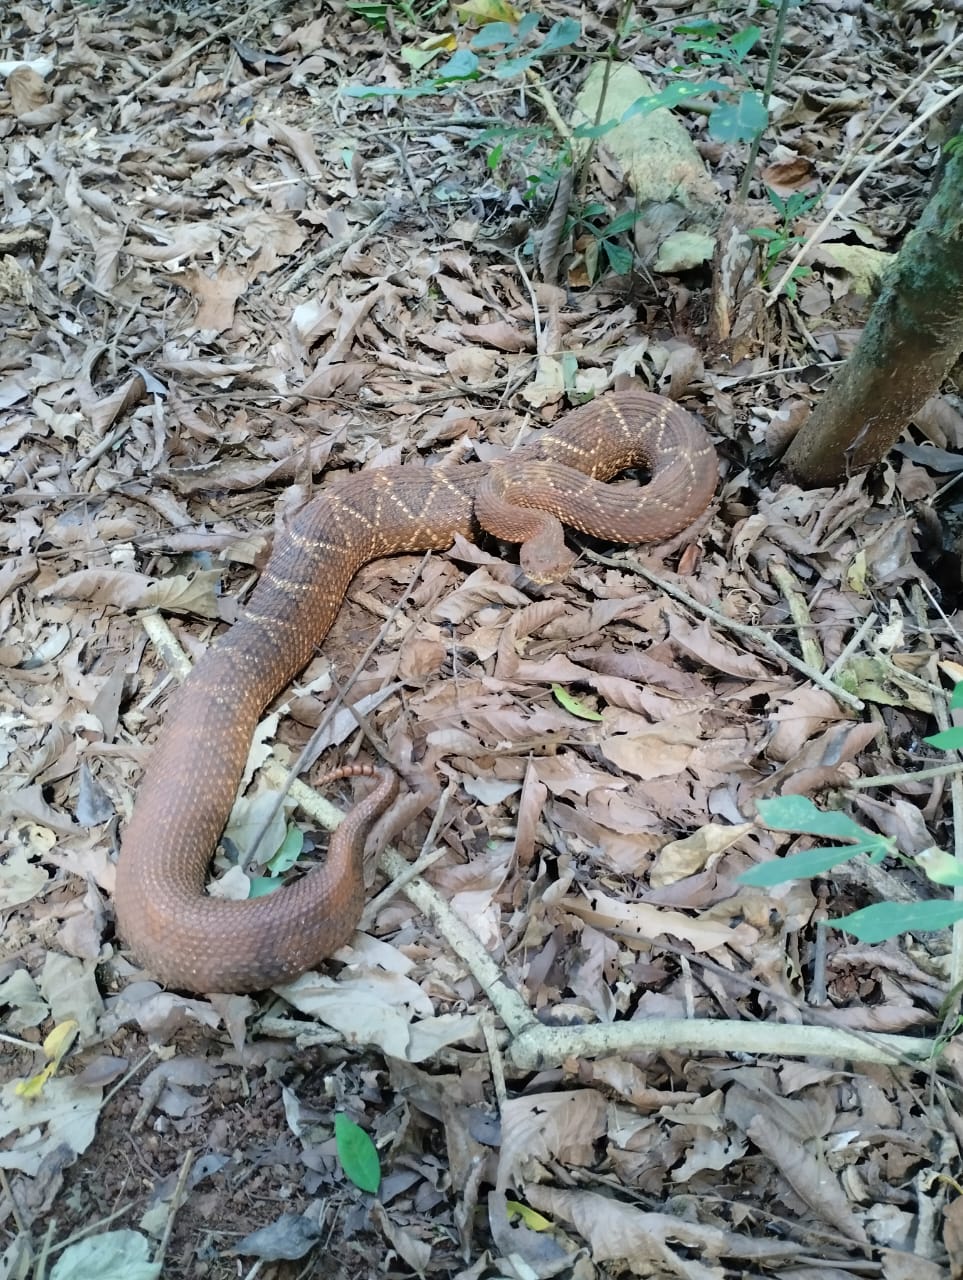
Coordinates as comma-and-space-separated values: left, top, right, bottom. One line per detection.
114, 390, 718, 992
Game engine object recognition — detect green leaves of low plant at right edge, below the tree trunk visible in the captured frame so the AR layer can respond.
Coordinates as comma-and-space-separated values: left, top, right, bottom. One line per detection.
739, 682, 963, 942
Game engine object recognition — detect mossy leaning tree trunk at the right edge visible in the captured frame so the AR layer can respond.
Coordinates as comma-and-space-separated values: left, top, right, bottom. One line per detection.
785, 126, 963, 485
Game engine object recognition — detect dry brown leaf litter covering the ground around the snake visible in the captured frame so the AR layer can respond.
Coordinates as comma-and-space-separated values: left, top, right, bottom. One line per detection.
0, 0, 963, 1280
